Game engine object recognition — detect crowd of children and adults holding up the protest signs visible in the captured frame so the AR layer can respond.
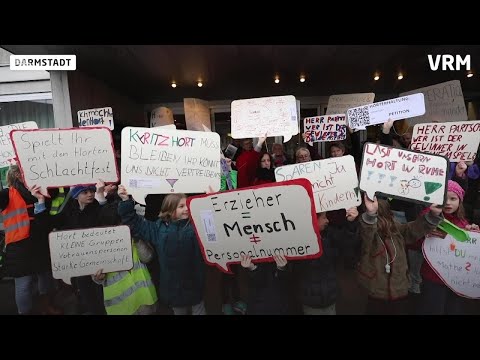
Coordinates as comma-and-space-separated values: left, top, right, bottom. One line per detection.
0, 121, 480, 315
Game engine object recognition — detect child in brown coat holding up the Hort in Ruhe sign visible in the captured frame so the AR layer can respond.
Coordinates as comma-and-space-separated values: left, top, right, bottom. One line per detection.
357, 194, 443, 315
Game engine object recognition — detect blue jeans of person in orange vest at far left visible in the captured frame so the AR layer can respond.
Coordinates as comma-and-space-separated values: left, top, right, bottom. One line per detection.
15, 271, 53, 314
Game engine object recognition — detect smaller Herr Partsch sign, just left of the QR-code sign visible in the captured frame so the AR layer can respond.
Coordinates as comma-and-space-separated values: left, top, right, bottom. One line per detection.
303, 114, 347, 145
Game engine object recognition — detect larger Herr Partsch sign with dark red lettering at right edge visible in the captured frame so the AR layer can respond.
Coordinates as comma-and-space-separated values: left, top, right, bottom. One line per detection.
410, 121, 480, 162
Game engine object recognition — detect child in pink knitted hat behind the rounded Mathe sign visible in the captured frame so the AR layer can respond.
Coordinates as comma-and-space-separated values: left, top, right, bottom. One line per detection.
418, 180, 478, 315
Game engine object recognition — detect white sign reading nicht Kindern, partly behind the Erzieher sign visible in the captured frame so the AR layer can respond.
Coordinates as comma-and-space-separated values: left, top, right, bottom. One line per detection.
275, 155, 362, 213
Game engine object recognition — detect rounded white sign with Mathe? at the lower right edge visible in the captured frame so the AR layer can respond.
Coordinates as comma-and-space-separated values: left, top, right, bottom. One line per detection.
423, 232, 480, 299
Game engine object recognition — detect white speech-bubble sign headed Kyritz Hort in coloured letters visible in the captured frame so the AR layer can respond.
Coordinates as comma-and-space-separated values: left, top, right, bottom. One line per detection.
122, 127, 220, 204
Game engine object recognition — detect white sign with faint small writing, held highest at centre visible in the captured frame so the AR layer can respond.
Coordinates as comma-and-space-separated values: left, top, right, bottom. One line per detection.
231, 95, 298, 142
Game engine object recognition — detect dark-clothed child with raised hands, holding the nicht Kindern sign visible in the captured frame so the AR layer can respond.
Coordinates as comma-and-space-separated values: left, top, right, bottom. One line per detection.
295, 207, 358, 315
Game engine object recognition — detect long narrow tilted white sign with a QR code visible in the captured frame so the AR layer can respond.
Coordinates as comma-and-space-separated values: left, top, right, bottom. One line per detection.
347, 93, 425, 129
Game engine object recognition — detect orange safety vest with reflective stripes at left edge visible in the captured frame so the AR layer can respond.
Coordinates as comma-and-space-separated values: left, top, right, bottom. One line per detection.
2, 187, 33, 245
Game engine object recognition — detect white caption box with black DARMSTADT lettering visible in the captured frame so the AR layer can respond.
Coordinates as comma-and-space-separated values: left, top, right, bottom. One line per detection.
10, 55, 77, 70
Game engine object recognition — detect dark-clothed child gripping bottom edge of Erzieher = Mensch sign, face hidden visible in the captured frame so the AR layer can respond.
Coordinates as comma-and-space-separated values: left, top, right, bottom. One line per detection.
241, 255, 289, 315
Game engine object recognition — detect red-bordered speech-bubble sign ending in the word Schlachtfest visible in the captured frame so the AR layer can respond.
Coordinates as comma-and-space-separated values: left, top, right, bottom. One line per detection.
11, 127, 118, 194
